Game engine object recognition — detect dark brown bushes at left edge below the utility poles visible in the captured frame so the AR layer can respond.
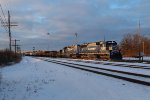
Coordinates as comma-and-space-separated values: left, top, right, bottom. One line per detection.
0, 49, 21, 65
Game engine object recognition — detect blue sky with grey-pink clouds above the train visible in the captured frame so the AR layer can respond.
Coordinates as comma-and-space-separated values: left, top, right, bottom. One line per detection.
0, 0, 150, 50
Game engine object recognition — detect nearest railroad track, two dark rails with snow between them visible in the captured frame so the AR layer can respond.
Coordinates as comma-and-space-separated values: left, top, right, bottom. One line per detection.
37, 59, 150, 86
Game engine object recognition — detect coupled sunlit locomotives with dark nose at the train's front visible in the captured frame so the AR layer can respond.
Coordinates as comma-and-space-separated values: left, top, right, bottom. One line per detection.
58, 41, 122, 60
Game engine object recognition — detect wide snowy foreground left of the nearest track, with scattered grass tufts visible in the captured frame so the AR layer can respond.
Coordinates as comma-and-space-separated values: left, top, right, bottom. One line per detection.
0, 57, 150, 100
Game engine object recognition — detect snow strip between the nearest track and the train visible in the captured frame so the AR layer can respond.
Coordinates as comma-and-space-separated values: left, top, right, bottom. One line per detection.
39, 57, 150, 75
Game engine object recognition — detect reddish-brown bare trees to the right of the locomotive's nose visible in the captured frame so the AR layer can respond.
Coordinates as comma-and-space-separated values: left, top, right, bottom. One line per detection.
120, 33, 150, 57
